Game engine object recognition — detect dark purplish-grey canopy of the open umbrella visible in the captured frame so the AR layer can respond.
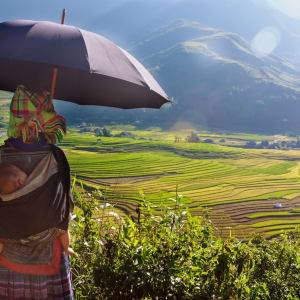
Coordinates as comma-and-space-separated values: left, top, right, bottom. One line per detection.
0, 20, 169, 108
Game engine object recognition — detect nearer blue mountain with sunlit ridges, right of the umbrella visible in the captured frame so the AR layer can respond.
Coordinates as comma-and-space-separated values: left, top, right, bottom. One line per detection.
131, 21, 300, 131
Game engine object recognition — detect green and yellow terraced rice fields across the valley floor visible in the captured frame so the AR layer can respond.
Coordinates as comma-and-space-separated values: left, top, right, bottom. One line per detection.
0, 94, 300, 238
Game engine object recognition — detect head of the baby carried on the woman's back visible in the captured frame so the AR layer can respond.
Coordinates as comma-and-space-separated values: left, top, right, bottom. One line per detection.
0, 163, 27, 195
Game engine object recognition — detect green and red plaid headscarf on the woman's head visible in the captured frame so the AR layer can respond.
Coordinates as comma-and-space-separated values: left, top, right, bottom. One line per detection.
7, 85, 66, 144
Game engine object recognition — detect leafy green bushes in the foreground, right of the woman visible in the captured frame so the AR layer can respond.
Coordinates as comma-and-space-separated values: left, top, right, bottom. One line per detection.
72, 189, 300, 300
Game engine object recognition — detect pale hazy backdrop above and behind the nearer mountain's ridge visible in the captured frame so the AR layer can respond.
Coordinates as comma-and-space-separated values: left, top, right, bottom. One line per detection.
0, 0, 300, 64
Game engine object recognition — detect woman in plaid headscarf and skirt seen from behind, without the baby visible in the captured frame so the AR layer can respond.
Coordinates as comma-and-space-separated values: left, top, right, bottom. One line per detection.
0, 86, 74, 300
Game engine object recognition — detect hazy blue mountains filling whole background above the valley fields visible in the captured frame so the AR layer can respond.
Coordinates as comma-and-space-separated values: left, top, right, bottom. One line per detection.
0, 0, 300, 132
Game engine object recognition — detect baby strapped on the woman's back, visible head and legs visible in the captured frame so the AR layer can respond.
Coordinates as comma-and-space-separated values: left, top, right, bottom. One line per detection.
0, 163, 74, 254
